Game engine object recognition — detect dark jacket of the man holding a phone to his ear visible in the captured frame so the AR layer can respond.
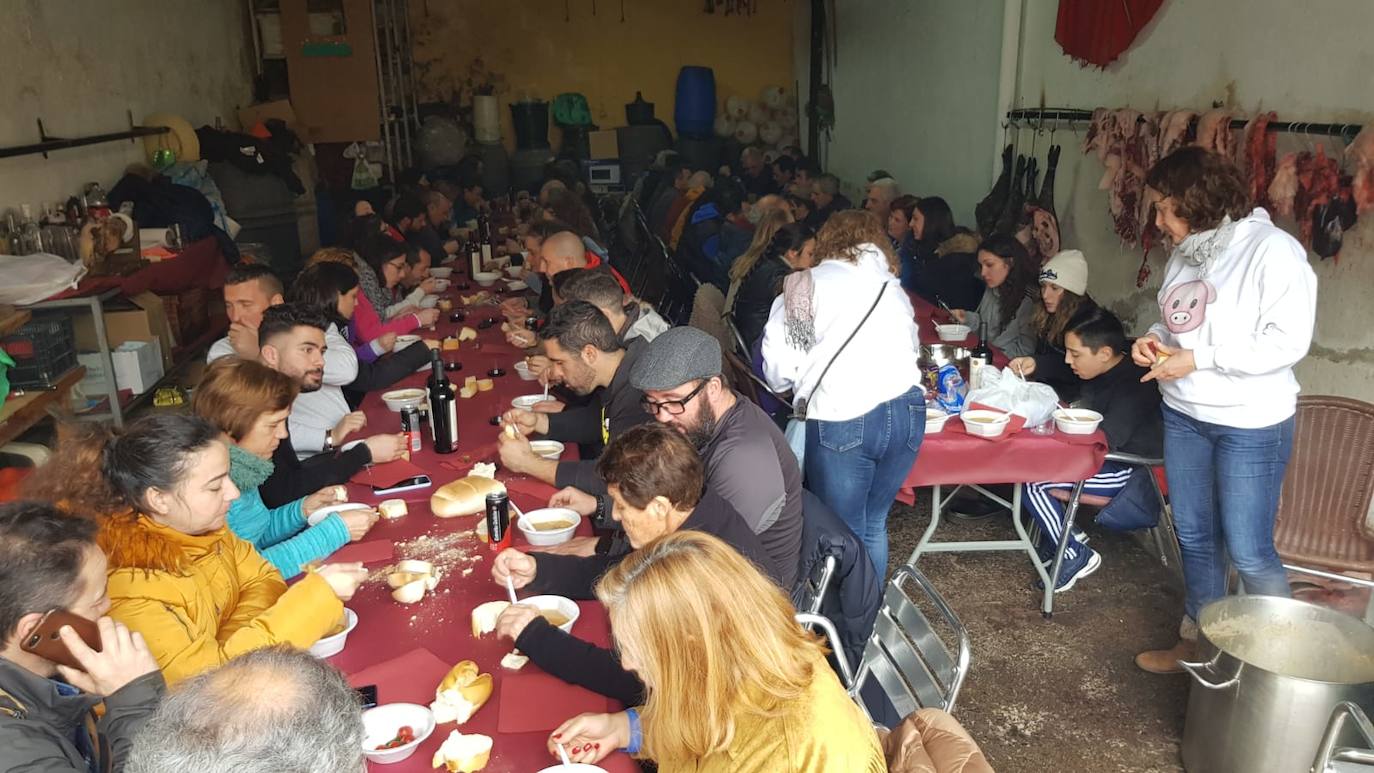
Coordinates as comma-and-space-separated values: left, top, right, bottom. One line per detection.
0, 658, 166, 773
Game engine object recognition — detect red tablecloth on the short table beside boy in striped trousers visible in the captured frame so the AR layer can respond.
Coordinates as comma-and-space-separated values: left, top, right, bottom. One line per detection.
897, 417, 1107, 504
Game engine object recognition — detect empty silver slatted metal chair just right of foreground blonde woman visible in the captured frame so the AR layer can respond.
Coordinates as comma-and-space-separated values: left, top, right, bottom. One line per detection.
849, 566, 970, 717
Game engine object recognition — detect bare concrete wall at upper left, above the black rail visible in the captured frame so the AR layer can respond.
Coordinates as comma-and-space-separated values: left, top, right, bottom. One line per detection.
0, 0, 251, 208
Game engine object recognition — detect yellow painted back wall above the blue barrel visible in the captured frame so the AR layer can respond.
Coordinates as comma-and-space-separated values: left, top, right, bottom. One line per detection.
411, 0, 800, 150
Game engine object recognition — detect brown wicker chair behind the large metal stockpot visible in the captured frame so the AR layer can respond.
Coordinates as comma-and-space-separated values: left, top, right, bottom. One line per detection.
1274, 395, 1374, 621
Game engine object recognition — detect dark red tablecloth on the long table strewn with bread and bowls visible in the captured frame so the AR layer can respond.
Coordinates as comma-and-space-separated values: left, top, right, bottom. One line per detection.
330, 272, 638, 773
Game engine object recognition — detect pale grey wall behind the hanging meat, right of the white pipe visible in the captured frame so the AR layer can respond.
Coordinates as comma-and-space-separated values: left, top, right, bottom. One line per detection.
1020, 0, 1374, 401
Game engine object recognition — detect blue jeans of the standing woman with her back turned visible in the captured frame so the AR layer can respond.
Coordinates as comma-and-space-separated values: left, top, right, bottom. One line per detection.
804, 387, 926, 577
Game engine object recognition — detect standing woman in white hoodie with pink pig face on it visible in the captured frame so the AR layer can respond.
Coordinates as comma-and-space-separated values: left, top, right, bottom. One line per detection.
1131, 147, 1316, 673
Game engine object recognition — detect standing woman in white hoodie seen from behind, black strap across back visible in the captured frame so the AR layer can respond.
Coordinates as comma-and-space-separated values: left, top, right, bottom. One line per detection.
763, 210, 926, 575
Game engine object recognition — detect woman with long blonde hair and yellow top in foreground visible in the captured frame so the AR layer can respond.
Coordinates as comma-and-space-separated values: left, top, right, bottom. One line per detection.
550, 531, 886, 773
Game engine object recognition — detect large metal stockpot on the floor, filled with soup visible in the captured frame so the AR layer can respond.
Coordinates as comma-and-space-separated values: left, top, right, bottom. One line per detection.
1182, 596, 1374, 773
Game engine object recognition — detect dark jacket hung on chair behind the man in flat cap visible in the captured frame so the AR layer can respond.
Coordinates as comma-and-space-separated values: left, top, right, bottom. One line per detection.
791, 490, 882, 671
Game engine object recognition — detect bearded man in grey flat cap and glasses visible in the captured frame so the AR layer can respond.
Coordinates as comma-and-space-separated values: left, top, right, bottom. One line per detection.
629, 327, 802, 588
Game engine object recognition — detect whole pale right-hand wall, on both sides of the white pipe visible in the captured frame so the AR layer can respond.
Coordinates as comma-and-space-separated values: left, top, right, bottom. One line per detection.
818, 0, 1374, 401
